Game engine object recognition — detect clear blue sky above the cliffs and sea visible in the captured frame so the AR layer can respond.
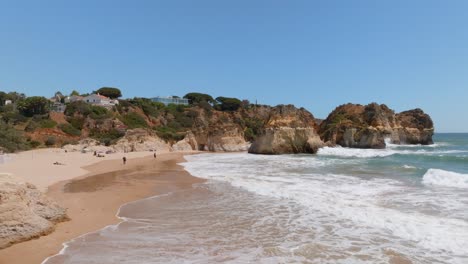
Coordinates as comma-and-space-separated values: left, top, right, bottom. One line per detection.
0, 0, 468, 132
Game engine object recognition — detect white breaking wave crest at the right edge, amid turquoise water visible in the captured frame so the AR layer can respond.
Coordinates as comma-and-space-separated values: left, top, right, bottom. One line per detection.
423, 169, 468, 188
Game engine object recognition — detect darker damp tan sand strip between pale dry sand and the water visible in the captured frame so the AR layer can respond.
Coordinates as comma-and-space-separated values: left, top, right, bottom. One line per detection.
0, 152, 204, 264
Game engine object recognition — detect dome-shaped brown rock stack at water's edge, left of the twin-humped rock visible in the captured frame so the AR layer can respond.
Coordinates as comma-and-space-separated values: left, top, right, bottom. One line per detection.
249, 105, 324, 154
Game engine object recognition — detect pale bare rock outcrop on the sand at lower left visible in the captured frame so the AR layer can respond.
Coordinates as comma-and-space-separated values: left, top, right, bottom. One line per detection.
0, 174, 68, 249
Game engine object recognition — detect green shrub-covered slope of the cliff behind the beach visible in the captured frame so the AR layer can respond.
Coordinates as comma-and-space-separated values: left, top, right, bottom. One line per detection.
0, 87, 262, 152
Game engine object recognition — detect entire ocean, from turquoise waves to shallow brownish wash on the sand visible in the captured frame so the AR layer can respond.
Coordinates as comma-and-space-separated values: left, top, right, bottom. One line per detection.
44, 134, 468, 264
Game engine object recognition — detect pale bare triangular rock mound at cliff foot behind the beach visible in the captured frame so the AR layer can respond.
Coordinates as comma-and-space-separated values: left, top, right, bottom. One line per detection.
113, 128, 172, 152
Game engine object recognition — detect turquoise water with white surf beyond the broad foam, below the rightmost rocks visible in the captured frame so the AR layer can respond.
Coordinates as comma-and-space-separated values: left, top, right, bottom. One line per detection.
318, 133, 468, 184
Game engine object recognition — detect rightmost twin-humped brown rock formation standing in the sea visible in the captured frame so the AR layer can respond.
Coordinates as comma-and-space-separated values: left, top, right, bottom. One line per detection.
319, 103, 434, 148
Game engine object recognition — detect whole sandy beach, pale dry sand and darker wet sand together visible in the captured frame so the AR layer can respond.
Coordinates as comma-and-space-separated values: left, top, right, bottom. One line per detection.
0, 149, 202, 264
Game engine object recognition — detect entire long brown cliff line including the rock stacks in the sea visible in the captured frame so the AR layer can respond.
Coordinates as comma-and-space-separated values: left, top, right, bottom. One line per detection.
0, 93, 434, 154
